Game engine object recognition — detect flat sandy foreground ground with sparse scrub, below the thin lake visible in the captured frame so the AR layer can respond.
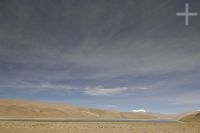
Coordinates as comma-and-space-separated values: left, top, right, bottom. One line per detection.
0, 121, 200, 133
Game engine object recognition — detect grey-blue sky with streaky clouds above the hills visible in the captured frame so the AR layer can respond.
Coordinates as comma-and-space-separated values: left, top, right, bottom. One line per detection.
0, 0, 200, 113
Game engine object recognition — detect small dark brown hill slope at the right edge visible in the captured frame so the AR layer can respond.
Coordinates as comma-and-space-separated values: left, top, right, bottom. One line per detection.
180, 112, 200, 122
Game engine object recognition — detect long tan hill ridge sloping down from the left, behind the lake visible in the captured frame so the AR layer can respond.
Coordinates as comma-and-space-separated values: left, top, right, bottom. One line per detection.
0, 99, 157, 119
